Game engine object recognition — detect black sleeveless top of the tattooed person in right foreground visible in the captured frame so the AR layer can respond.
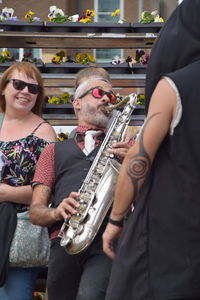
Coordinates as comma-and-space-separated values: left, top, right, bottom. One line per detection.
106, 61, 200, 300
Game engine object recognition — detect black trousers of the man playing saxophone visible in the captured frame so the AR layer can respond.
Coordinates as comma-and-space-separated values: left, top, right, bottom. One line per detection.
47, 235, 112, 300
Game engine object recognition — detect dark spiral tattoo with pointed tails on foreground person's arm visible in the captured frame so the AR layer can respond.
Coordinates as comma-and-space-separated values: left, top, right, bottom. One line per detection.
127, 113, 159, 202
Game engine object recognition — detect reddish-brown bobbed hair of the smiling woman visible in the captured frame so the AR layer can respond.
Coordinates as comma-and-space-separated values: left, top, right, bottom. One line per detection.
0, 62, 44, 116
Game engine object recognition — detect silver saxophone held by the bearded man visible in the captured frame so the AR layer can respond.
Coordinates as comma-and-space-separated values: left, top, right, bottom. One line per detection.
58, 94, 137, 254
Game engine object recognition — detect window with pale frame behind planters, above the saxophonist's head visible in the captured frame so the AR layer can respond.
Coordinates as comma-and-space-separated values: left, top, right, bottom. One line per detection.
94, 0, 124, 63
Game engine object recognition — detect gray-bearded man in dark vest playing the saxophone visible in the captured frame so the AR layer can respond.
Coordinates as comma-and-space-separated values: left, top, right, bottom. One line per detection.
30, 72, 130, 300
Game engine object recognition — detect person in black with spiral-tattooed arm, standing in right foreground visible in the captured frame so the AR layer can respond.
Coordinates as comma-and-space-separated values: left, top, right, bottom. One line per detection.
103, 0, 200, 300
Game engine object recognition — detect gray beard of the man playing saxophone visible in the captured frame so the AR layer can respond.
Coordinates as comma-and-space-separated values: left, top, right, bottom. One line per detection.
81, 105, 110, 128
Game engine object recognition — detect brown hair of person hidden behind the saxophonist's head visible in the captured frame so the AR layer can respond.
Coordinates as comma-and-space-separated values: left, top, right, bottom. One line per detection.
75, 66, 110, 89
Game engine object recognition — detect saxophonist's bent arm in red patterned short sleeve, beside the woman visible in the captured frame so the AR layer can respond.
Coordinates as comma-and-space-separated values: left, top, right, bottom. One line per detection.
30, 144, 79, 226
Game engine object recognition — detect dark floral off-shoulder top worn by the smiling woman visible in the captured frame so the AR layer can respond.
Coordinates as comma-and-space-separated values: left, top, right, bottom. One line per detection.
0, 122, 52, 210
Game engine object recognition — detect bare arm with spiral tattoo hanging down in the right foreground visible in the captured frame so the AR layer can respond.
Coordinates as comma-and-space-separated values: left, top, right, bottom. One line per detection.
103, 79, 176, 258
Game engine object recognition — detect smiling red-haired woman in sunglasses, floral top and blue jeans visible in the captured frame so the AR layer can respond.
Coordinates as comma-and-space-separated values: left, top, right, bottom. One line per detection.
0, 62, 56, 300
